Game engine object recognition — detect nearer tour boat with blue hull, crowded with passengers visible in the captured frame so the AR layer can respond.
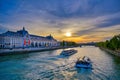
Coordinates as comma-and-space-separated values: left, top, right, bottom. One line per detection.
75, 56, 92, 69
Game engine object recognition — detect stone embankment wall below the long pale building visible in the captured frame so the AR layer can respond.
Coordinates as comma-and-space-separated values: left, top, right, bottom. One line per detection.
0, 47, 69, 55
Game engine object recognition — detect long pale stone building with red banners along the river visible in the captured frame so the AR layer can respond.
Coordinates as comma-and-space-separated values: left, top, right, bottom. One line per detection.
0, 27, 59, 49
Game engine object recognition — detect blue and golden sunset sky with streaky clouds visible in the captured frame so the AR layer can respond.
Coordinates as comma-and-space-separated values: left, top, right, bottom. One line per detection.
0, 0, 120, 43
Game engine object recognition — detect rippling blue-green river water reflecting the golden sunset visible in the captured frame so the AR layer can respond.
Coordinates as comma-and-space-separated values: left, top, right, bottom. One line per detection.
0, 46, 120, 80
